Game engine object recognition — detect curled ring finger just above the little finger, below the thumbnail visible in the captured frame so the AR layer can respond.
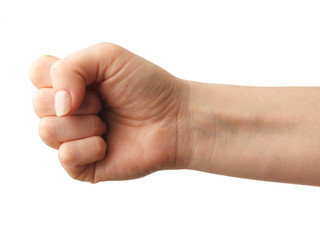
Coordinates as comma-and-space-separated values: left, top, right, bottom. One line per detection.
39, 115, 106, 149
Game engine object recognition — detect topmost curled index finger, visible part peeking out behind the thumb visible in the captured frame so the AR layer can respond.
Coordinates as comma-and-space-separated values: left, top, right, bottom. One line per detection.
29, 55, 59, 88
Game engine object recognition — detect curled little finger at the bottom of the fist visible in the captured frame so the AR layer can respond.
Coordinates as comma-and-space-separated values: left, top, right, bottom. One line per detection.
59, 136, 107, 182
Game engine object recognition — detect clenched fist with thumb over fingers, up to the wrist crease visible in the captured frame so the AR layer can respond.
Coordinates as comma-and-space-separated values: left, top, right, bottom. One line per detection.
30, 43, 189, 183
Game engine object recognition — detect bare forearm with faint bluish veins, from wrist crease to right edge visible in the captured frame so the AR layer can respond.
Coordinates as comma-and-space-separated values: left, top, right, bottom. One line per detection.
180, 82, 320, 185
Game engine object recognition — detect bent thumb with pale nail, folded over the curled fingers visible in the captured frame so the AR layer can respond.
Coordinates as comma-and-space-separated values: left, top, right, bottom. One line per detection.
50, 43, 130, 116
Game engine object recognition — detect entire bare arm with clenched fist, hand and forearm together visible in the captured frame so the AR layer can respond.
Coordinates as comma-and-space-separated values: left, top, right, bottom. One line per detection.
30, 43, 320, 185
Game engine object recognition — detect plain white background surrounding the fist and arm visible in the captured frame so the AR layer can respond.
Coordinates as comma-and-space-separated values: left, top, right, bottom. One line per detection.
0, 0, 320, 239
